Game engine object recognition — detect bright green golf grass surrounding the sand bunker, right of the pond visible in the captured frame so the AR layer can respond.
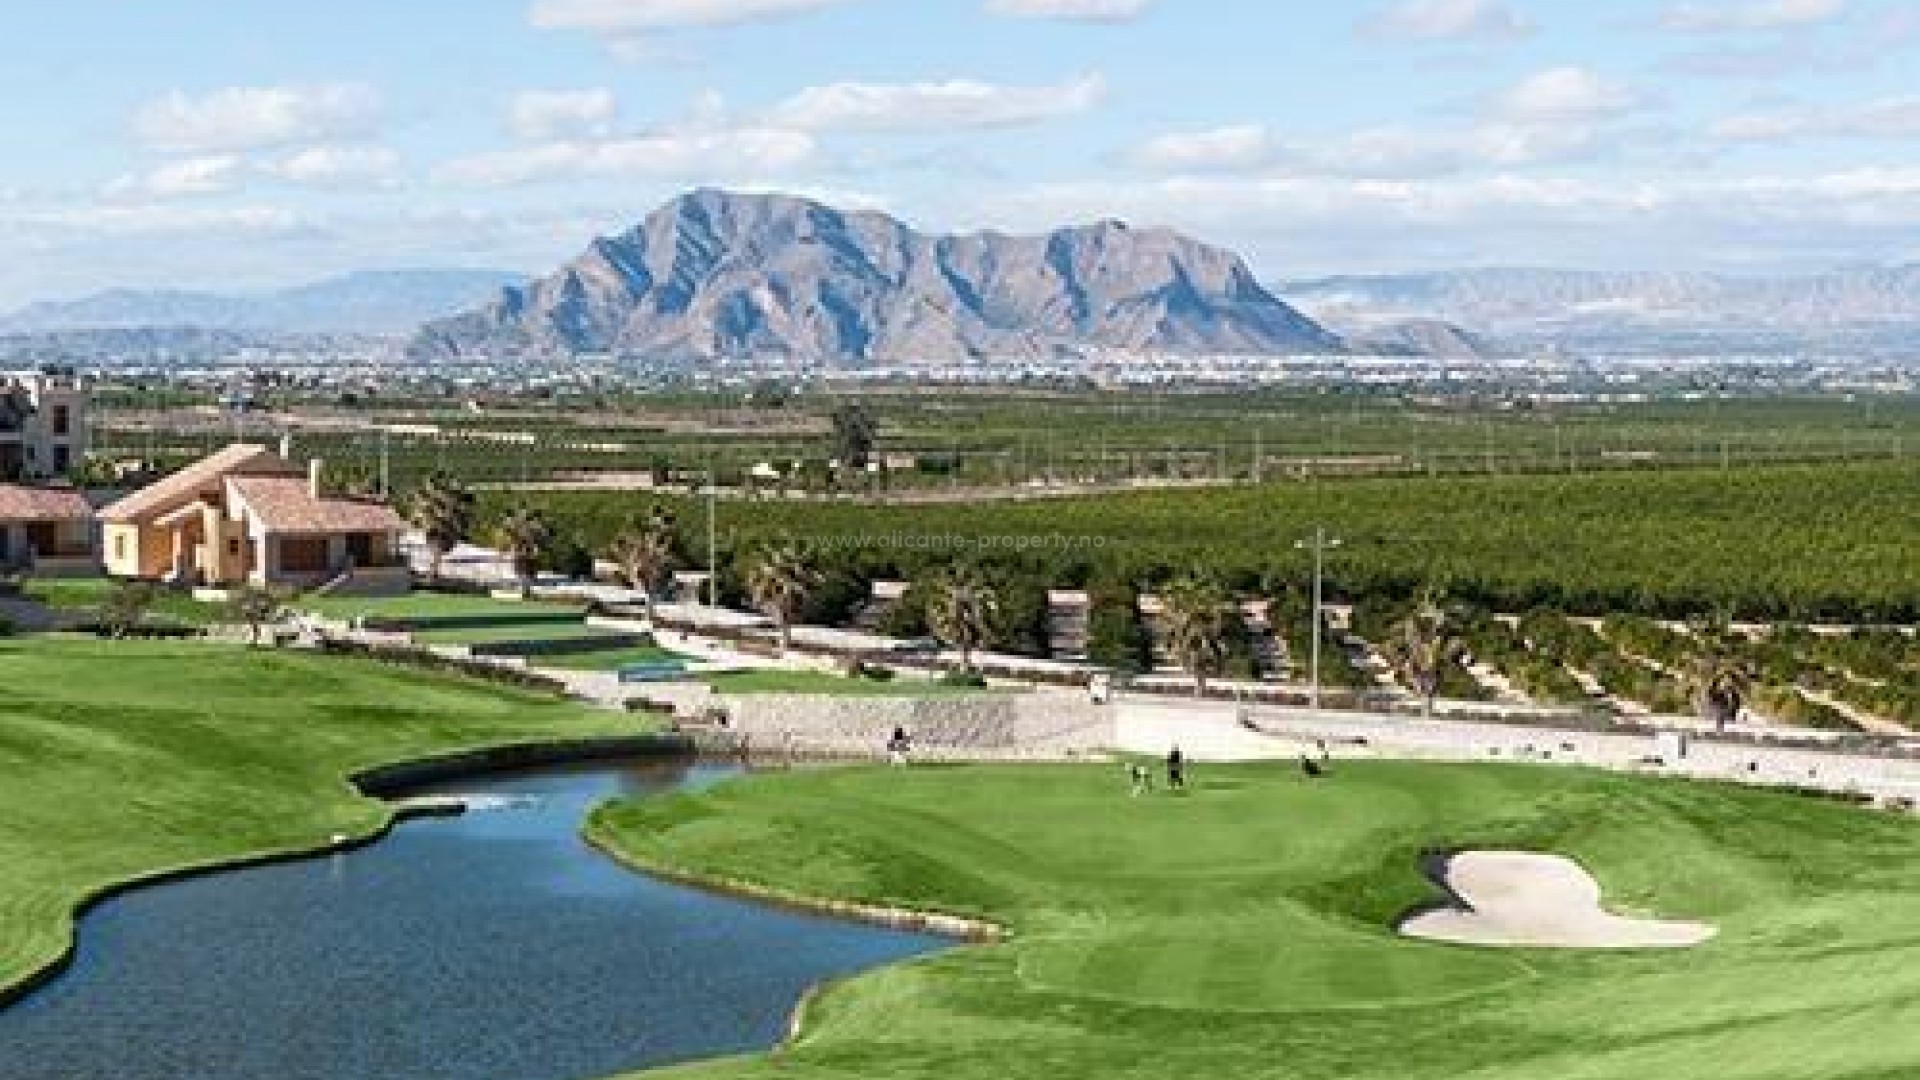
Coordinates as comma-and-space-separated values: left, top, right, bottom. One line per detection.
593, 763, 1920, 1080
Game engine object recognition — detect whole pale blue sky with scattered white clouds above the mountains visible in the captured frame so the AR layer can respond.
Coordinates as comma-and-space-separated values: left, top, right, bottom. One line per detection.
0, 0, 1920, 309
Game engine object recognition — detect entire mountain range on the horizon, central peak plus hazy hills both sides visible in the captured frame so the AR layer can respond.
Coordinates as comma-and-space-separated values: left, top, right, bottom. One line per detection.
0, 190, 1920, 367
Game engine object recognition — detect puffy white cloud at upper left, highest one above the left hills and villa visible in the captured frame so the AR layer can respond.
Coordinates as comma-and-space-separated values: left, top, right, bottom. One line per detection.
132, 83, 380, 154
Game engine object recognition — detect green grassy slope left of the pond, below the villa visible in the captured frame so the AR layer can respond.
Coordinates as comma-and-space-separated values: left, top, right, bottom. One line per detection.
0, 640, 634, 986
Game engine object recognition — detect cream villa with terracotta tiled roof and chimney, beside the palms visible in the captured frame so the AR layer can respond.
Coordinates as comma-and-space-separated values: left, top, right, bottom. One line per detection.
100, 444, 411, 596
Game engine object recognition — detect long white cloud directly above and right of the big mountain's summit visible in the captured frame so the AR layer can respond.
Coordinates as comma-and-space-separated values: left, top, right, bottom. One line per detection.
766, 75, 1106, 133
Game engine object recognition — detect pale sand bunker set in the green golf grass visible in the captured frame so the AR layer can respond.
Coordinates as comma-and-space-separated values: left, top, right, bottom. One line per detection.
1400, 851, 1715, 949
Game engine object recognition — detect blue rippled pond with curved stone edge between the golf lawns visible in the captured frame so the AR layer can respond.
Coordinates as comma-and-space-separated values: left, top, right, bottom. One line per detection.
0, 763, 948, 1080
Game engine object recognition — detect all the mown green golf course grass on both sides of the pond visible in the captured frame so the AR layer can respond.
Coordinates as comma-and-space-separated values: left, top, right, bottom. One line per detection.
0, 638, 1920, 1080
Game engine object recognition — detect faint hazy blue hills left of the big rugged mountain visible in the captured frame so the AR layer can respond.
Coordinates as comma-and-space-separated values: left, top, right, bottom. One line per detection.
0, 271, 524, 334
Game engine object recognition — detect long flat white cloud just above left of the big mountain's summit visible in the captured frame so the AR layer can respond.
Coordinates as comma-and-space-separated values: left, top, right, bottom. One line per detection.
436, 127, 816, 186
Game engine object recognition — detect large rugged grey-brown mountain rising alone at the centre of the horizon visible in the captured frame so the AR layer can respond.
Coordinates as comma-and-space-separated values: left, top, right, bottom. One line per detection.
413, 190, 1340, 365
